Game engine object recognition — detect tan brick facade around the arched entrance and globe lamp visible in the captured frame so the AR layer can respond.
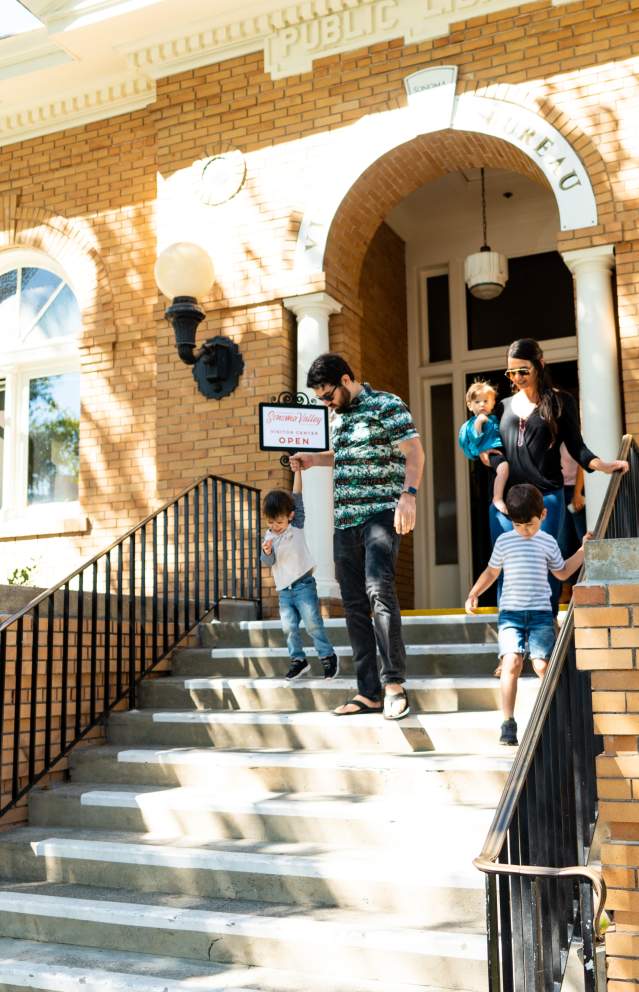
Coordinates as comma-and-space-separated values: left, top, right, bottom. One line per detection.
0, 0, 639, 605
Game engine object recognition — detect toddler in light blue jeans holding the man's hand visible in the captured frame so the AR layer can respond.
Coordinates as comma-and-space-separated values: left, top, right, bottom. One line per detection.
261, 471, 339, 679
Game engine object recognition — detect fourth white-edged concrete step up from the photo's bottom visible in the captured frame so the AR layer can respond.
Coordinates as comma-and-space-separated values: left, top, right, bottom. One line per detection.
29, 784, 493, 844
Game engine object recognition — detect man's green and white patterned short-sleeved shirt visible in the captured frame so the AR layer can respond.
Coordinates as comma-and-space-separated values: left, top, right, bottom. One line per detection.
331, 383, 419, 530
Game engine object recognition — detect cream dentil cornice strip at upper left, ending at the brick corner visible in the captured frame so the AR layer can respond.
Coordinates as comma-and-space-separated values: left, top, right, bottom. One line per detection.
0, 75, 156, 145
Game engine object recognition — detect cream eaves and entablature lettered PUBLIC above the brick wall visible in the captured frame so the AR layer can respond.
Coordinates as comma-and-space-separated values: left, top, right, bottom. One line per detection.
0, 0, 561, 145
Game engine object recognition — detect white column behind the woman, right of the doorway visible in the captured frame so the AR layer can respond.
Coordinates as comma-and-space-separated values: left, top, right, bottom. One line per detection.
563, 245, 623, 528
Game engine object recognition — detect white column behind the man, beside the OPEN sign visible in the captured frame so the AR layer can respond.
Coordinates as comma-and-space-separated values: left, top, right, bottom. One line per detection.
283, 293, 342, 598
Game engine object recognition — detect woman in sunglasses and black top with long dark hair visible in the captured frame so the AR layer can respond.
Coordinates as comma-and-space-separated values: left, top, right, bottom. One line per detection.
482, 338, 628, 615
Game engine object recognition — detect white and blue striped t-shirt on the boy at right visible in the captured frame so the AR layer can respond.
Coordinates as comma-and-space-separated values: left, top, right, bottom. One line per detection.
488, 530, 566, 610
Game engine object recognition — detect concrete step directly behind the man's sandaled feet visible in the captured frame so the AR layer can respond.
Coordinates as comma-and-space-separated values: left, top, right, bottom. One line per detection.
140, 676, 539, 713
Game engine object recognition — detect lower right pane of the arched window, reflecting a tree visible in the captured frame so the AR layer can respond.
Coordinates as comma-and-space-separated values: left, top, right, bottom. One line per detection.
27, 372, 80, 503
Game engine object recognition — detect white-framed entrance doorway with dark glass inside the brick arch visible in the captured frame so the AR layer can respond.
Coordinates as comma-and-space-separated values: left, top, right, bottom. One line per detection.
387, 169, 577, 609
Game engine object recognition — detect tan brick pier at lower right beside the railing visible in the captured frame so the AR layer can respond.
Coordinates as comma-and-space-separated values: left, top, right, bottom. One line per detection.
575, 582, 639, 992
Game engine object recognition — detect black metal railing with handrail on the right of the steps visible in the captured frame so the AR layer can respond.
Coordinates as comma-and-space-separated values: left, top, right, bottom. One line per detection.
474, 435, 639, 992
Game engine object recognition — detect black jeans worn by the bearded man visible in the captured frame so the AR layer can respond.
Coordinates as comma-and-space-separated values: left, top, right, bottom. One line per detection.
333, 510, 406, 700
